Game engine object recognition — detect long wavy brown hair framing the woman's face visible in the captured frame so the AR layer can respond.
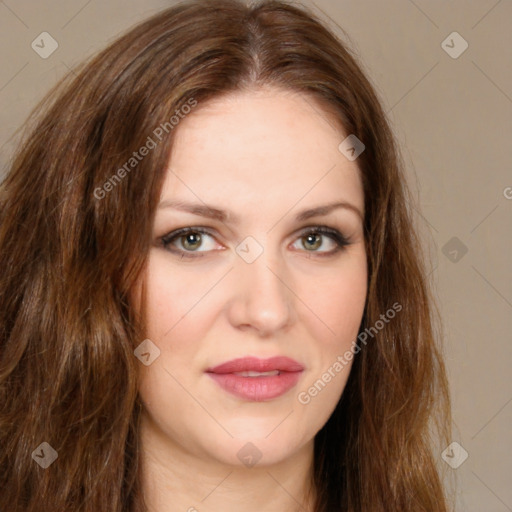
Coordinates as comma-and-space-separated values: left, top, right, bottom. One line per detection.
0, 0, 450, 512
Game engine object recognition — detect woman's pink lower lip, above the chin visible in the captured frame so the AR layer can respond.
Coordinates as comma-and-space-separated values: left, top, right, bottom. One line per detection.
208, 371, 302, 402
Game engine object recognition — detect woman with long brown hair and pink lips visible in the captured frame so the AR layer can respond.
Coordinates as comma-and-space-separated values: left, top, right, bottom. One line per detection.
0, 0, 449, 512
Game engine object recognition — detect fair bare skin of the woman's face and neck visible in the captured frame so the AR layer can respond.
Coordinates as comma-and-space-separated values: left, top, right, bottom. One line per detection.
136, 88, 367, 512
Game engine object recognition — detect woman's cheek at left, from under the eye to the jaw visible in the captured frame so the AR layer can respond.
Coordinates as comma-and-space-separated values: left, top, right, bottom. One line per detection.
139, 251, 211, 422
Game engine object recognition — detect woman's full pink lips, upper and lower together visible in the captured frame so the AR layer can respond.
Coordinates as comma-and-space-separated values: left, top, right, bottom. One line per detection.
206, 356, 304, 402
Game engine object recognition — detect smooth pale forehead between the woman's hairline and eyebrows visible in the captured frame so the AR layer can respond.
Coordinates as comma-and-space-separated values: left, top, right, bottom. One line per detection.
162, 89, 364, 214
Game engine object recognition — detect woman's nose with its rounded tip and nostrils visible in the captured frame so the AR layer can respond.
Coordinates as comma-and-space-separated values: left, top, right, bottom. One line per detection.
228, 243, 295, 337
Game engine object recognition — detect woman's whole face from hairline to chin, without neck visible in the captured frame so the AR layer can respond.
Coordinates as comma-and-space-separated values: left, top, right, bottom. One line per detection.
136, 89, 367, 465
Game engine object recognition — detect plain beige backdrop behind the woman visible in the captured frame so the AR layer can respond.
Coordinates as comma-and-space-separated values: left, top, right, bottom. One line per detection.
0, 0, 512, 512
